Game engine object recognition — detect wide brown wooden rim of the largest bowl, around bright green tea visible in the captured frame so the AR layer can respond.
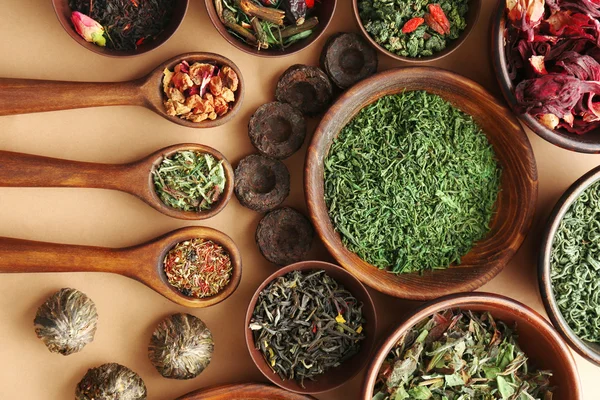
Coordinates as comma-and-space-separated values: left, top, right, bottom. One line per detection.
304, 66, 538, 301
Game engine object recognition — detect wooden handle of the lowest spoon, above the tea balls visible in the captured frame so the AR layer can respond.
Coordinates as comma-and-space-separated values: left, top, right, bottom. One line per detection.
0, 237, 131, 274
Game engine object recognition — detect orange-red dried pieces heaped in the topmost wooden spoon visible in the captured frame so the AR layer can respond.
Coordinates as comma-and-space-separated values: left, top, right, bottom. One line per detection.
163, 61, 239, 122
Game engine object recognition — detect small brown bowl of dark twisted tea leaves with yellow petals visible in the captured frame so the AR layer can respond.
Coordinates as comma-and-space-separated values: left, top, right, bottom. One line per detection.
246, 261, 377, 394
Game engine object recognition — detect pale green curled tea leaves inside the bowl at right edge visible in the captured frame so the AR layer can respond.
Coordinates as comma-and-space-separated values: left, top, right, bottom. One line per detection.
550, 182, 600, 343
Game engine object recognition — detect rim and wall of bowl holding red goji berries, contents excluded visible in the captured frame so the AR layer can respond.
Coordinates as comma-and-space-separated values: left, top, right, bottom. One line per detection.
352, 0, 482, 64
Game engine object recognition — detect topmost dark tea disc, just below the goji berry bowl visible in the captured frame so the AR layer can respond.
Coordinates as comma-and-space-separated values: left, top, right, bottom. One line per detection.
321, 33, 378, 89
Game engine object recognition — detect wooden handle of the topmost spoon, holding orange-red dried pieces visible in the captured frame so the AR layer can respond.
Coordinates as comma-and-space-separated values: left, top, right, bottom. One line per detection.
0, 78, 144, 115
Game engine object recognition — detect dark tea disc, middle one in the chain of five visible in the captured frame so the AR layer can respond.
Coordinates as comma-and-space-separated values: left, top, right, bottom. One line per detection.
248, 101, 306, 160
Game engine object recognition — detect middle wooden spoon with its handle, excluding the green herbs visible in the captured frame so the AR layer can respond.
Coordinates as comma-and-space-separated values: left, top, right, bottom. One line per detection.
0, 143, 234, 220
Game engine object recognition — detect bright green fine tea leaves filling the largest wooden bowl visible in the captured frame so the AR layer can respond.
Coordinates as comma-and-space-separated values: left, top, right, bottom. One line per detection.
325, 91, 501, 273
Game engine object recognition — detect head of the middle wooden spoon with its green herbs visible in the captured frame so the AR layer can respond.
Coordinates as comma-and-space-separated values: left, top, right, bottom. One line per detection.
150, 144, 234, 219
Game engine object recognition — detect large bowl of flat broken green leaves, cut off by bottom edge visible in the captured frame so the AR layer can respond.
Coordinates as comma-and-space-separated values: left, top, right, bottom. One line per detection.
358, 293, 583, 400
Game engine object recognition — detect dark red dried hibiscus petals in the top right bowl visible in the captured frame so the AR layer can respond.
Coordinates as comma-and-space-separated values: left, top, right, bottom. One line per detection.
504, 0, 600, 134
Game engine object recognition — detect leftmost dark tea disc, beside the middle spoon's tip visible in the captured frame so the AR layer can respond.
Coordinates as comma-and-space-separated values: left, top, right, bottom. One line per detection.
234, 154, 290, 212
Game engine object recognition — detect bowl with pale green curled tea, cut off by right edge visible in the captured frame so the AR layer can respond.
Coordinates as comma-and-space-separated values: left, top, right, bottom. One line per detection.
538, 167, 600, 365
